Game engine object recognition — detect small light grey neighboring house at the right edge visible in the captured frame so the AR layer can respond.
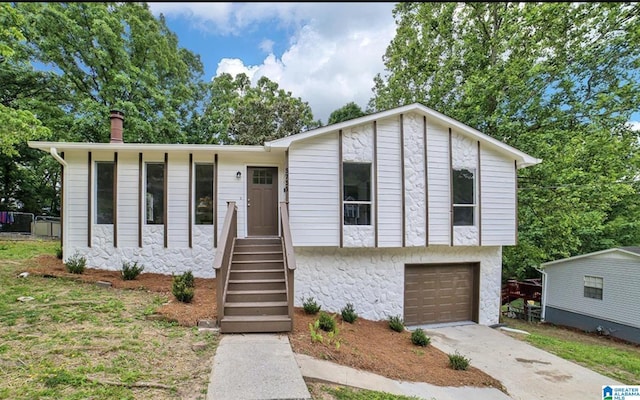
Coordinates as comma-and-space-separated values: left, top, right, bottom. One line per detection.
541, 247, 640, 343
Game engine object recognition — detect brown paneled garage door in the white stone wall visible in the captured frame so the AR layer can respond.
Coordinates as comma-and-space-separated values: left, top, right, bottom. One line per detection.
404, 264, 480, 325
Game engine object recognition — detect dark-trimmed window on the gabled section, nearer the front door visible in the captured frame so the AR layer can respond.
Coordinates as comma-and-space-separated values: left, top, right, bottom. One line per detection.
342, 163, 371, 225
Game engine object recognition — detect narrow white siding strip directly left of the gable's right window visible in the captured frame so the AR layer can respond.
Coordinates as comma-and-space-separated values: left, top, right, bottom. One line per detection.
427, 118, 452, 245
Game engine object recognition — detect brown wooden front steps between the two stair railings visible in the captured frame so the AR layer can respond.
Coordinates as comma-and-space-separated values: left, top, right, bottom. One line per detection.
219, 237, 292, 333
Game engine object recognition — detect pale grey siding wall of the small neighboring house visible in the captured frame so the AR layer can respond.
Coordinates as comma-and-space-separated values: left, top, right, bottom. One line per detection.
545, 253, 640, 328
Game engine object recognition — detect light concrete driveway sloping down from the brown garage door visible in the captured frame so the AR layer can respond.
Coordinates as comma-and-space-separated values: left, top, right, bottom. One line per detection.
424, 324, 622, 400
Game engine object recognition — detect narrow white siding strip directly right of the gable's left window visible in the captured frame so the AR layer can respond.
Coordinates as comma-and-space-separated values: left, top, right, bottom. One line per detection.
377, 116, 402, 247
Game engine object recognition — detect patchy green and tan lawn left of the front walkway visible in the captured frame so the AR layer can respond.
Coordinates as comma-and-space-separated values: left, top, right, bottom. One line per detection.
0, 241, 218, 399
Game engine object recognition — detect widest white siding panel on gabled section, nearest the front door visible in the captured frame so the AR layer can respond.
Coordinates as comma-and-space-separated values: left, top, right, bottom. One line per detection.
289, 132, 341, 246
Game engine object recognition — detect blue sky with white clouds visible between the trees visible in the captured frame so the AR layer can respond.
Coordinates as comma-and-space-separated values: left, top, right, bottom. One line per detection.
149, 2, 640, 130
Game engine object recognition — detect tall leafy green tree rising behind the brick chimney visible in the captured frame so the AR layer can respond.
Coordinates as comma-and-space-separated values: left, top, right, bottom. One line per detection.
14, 2, 203, 143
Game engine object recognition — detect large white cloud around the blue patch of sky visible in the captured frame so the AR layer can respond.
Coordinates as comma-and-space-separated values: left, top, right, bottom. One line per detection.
150, 3, 395, 123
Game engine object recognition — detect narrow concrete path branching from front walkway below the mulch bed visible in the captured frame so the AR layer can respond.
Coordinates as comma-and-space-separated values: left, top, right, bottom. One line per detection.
295, 354, 511, 400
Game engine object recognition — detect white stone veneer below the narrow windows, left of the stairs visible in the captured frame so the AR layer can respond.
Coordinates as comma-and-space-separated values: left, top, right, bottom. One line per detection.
70, 225, 216, 278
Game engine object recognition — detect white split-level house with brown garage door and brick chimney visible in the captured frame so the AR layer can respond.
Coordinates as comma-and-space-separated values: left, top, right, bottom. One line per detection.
29, 104, 540, 332
